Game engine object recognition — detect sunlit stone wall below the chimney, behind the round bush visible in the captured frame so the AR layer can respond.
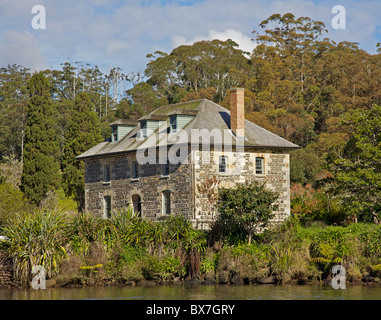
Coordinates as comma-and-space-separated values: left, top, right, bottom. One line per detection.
193, 150, 290, 229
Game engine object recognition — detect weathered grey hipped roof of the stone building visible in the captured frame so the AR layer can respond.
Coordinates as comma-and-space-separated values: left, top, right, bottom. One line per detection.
77, 99, 299, 159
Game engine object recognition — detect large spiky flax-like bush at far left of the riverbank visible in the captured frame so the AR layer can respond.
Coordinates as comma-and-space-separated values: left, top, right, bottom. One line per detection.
2, 210, 66, 281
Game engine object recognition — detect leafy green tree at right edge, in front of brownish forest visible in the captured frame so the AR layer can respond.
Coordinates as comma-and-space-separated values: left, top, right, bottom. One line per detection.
327, 106, 381, 222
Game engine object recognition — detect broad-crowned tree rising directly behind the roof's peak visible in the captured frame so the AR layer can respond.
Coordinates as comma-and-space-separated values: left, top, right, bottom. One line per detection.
145, 40, 250, 103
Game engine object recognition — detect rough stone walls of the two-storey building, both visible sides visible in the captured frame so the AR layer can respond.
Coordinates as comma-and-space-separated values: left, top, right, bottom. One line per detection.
85, 146, 290, 229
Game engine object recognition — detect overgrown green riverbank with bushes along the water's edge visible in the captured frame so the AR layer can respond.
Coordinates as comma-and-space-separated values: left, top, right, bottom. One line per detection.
0, 212, 381, 287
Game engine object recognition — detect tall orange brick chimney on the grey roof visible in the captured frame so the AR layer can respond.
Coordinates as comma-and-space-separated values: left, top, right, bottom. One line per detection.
230, 88, 245, 139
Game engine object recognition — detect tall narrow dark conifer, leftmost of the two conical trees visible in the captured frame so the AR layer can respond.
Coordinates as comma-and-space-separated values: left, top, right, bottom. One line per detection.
21, 72, 60, 205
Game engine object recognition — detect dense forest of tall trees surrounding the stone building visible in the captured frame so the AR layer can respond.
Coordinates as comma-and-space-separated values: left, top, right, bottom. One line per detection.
0, 13, 381, 224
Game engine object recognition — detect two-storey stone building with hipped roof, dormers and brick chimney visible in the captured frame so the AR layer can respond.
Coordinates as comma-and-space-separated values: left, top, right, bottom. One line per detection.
77, 88, 298, 228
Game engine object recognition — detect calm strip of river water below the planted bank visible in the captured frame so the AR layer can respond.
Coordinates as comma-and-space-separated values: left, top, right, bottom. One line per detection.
0, 284, 381, 300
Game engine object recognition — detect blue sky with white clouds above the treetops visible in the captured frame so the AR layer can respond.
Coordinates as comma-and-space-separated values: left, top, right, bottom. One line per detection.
0, 0, 381, 74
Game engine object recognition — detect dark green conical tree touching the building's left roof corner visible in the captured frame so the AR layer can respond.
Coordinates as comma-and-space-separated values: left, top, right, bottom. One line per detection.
62, 92, 102, 212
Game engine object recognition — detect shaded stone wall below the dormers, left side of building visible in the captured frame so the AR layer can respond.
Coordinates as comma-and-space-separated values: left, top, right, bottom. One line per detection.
85, 153, 194, 219
